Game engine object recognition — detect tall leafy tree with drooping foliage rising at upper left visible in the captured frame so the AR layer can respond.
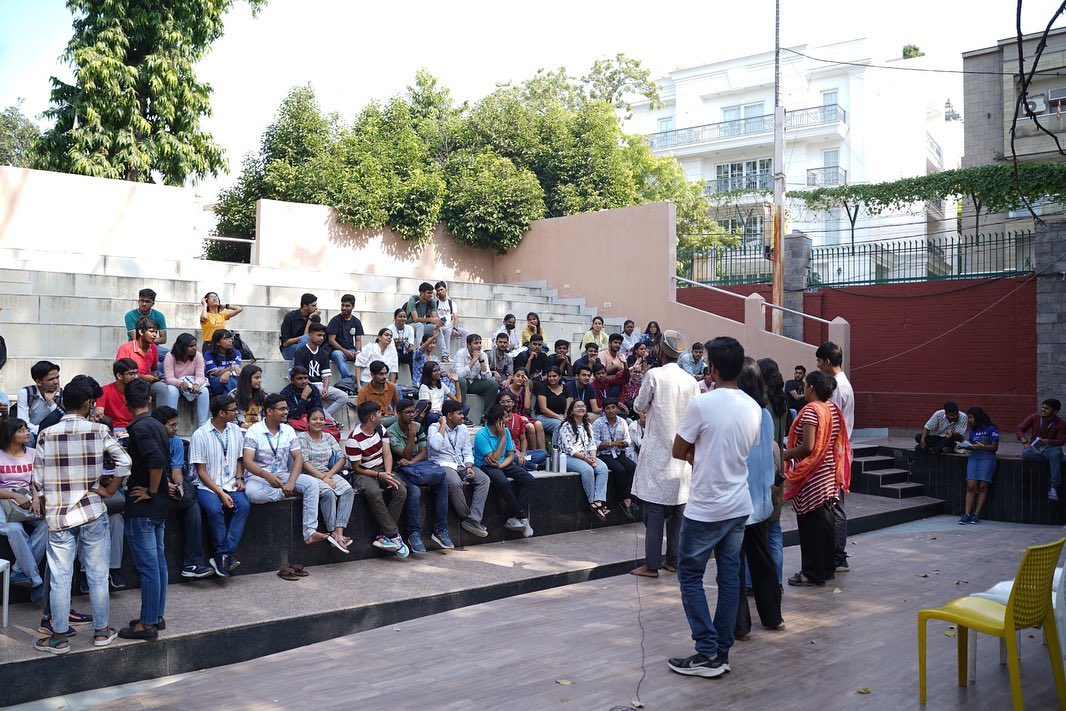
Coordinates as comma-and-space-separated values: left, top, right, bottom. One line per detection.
37, 0, 265, 185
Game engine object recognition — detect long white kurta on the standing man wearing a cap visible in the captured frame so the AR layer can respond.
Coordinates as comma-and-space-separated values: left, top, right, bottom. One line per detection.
632, 362, 699, 506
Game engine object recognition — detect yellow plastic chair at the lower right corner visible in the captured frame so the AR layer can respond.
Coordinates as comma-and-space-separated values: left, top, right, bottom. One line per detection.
918, 538, 1066, 711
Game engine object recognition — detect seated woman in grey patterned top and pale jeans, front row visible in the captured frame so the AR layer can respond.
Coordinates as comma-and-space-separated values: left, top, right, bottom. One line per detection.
296, 407, 355, 554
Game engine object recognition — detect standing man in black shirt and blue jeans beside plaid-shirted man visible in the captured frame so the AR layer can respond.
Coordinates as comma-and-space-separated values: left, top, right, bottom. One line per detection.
119, 381, 171, 640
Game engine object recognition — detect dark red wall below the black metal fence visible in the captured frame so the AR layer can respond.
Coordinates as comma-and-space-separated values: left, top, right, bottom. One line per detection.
677, 277, 1036, 432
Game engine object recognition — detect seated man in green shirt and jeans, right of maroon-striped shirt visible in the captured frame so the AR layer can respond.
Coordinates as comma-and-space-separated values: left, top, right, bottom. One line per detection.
386, 400, 455, 553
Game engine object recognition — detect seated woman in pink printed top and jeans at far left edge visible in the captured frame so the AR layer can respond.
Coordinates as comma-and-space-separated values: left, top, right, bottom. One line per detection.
0, 417, 48, 602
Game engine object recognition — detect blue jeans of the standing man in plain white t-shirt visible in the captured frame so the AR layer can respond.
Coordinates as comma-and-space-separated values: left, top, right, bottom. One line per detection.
677, 516, 747, 658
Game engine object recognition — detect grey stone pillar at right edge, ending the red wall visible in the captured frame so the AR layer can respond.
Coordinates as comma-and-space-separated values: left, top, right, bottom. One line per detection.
1033, 216, 1066, 400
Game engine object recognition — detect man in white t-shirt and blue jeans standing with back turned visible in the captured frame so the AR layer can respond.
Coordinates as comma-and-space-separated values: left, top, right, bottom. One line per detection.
668, 337, 762, 678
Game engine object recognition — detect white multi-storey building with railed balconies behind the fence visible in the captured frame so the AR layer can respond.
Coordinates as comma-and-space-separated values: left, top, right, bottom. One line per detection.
626, 39, 962, 283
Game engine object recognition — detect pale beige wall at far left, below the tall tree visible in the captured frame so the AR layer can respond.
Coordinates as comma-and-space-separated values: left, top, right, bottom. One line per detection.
0, 165, 203, 259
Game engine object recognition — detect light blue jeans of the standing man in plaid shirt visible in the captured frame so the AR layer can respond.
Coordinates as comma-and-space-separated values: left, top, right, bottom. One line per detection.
48, 515, 111, 634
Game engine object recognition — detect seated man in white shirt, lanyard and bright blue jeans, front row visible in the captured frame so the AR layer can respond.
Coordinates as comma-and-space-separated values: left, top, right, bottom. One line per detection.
189, 395, 252, 578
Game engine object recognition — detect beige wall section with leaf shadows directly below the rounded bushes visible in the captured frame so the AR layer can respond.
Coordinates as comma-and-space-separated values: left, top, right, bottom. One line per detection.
253, 200, 492, 281
